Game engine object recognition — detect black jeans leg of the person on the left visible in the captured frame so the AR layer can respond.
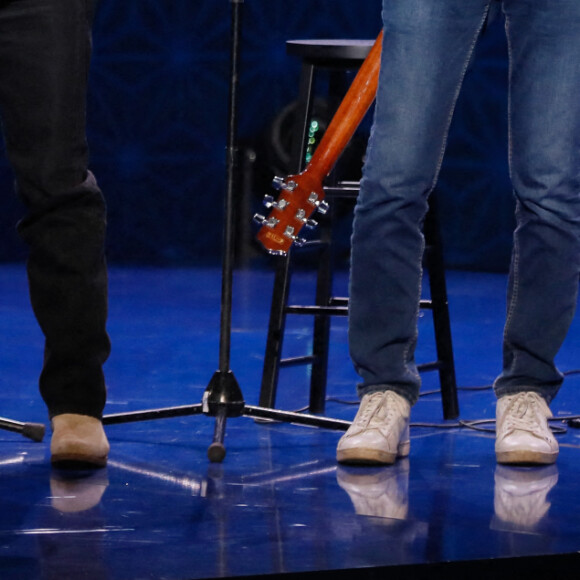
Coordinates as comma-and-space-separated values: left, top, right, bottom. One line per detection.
0, 0, 110, 418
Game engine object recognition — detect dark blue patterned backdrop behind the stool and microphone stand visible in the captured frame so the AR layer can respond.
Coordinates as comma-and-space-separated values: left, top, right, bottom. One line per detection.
0, 0, 513, 270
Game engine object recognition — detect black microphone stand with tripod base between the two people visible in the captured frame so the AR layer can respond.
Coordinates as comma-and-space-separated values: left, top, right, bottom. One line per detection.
103, 0, 350, 463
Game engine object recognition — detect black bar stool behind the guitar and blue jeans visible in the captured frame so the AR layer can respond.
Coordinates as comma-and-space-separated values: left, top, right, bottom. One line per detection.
259, 40, 459, 419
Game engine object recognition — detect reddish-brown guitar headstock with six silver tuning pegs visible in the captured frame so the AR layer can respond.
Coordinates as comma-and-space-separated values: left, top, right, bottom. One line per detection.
254, 171, 328, 256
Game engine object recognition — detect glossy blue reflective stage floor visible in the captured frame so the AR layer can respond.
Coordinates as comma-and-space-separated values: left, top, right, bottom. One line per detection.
0, 266, 580, 580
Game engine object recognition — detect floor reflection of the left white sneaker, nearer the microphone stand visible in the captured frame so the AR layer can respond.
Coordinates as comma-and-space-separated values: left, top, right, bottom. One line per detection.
336, 459, 409, 520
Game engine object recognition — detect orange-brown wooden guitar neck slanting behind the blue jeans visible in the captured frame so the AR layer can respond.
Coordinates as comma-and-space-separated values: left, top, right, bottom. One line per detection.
305, 32, 383, 181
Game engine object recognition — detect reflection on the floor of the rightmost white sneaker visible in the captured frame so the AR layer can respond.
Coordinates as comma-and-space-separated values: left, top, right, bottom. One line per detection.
494, 465, 558, 529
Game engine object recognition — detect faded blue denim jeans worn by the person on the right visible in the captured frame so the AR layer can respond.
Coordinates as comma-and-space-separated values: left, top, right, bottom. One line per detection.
349, 0, 580, 404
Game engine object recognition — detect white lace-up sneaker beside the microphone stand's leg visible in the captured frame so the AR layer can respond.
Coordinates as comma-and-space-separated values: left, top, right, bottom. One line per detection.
336, 391, 411, 465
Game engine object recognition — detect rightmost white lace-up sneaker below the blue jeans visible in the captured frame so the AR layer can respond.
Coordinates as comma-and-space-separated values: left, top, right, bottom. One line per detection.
495, 392, 558, 464
